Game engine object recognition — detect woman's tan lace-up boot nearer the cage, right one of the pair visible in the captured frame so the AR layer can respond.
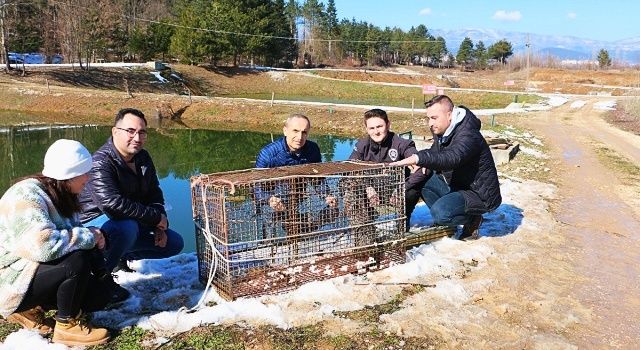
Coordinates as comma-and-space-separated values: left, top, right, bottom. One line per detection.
52, 314, 109, 346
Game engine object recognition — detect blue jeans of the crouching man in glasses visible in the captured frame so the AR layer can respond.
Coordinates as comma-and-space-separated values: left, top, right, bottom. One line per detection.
84, 215, 184, 271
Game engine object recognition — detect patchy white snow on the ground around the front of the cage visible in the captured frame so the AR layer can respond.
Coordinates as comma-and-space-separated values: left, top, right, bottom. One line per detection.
0, 176, 555, 350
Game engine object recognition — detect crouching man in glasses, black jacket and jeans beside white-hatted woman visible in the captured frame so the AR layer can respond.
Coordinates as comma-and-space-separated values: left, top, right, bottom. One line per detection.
80, 108, 184, 271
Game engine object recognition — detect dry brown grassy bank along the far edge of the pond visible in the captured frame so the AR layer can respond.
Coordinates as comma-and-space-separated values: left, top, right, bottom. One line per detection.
0, 77, 536, 136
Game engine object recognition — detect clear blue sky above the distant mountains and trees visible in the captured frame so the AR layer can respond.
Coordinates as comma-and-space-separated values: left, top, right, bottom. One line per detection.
336, 0, 640, 41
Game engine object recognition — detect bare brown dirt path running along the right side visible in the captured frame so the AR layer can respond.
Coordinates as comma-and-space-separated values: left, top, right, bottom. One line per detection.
528, 103, 640, 349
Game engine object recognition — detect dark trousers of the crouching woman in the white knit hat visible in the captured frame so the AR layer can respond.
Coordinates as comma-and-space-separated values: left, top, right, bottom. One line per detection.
16, 249, 110, 319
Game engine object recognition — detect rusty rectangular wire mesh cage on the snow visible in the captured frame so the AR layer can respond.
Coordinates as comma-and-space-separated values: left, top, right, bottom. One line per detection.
191, 161, 406, 300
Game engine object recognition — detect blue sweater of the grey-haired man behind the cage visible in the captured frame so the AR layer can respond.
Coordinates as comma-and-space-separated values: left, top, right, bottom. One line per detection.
256, 137, 322, 168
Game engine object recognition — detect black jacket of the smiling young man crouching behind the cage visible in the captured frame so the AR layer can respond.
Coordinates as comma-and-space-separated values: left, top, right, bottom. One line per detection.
349, 132, 427, 189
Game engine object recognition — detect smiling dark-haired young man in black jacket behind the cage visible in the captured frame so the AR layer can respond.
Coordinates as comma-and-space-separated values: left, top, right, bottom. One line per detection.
349, 108, 426, 229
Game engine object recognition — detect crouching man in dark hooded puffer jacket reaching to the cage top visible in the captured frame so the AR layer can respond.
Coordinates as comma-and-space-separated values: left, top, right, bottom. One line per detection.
391, 95, 502, 239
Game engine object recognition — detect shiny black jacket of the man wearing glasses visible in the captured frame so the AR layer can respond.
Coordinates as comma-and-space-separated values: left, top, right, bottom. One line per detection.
80, 138, 166, 226
